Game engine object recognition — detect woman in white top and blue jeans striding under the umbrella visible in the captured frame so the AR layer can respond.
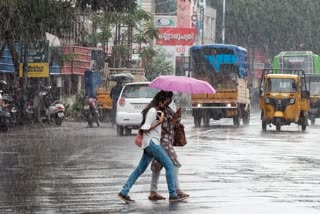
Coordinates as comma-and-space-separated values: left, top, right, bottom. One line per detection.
118, 91, 186, 203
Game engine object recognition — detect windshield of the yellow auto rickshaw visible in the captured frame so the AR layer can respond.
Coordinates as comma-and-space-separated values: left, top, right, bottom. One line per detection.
267, 78, 296, 93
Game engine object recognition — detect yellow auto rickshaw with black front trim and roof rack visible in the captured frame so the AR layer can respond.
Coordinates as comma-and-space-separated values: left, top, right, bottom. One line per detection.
259, 69, 310, 131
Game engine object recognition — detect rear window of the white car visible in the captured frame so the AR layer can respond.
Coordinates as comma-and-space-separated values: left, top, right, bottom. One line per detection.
122, 84, 159, 98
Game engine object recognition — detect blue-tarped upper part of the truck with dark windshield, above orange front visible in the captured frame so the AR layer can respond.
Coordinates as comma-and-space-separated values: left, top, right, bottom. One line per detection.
189, 44, 248, 89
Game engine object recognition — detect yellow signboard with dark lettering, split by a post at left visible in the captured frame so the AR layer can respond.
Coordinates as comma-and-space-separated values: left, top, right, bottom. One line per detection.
19, 62, 49, 78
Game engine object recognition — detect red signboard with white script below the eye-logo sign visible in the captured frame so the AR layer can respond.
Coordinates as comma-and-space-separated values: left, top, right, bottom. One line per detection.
156, 28, 197, 46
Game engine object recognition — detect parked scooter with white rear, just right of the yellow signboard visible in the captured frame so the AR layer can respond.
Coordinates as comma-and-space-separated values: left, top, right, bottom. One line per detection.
39, 86, 65, 126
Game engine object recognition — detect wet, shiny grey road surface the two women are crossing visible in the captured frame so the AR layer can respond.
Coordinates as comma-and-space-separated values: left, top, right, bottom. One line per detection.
0, 114, 320, 214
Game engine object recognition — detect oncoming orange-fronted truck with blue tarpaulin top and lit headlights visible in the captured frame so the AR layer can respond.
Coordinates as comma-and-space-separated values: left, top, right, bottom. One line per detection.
189, 44, 250, 127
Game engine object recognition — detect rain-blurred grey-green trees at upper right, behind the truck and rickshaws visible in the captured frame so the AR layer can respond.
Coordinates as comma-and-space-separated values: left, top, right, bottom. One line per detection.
211, 0, 320, 56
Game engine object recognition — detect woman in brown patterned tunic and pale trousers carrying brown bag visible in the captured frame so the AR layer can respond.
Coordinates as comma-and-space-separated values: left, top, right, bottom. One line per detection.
148, 91, 189, 201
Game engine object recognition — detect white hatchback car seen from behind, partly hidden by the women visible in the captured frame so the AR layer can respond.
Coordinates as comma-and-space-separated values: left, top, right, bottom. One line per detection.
116, 82, 159, 136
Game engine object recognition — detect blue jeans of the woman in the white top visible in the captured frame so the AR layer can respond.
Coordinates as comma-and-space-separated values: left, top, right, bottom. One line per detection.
121, 141, 177, 197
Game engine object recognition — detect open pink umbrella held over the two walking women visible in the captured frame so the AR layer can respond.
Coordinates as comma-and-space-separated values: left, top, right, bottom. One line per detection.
149, 76, 216, 94
